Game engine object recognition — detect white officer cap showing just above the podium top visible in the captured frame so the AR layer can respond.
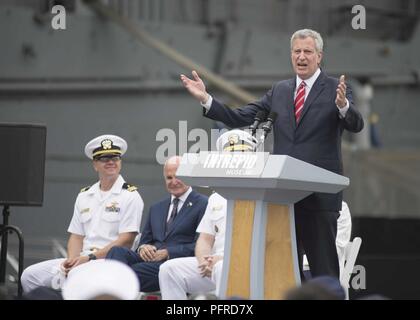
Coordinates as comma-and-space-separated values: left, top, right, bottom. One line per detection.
216, 129, 257, 152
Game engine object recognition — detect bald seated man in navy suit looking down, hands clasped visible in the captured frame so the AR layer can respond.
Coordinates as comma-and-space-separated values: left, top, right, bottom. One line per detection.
106, 156, 207, 292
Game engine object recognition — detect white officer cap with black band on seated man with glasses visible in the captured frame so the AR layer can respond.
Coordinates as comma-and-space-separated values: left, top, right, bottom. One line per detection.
85, 134, 127, 159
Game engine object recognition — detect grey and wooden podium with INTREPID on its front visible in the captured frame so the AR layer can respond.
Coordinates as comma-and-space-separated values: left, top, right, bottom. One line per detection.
177, 152, 349, 299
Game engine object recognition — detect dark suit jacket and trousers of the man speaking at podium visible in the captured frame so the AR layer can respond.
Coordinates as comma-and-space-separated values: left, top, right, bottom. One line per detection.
205, 72, 363, 277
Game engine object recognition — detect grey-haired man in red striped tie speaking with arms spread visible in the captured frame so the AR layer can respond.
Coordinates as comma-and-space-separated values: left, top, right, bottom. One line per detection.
181, 29, 363, 277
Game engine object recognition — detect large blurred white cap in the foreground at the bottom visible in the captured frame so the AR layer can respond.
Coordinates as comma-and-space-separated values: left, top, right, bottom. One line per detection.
62, 259, 140, 300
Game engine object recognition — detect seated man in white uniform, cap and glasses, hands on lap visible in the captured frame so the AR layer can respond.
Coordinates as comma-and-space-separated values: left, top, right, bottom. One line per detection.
21, 135, 144, 293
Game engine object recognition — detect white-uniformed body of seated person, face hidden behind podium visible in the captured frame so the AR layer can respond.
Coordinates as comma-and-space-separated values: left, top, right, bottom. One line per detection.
159, 193, 227, 300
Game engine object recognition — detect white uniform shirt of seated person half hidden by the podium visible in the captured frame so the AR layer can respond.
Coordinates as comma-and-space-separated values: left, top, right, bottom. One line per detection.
197, 193, 227, 256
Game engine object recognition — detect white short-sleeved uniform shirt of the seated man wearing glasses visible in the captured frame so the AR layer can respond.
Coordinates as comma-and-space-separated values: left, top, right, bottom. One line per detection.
67, 176, 144, 254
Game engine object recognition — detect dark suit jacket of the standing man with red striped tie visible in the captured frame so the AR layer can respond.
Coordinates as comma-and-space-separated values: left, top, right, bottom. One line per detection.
205, 72, 363, 211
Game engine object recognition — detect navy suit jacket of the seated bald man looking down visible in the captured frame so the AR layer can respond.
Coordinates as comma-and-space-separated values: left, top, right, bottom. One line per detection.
140, 190, 208, 259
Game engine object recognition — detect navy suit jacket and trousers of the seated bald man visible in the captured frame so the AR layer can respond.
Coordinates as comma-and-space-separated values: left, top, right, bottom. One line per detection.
106, 190, 207, 292
